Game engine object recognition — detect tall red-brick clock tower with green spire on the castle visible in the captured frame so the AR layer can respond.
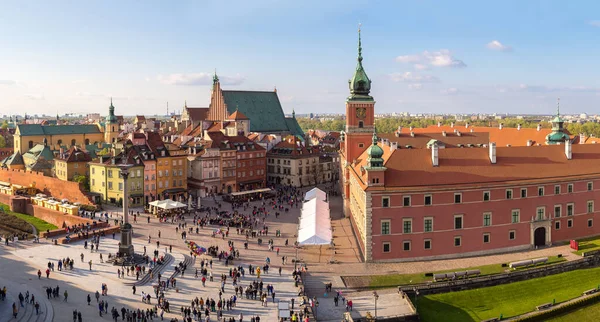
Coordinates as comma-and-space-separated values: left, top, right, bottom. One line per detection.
344, 28, 375, 162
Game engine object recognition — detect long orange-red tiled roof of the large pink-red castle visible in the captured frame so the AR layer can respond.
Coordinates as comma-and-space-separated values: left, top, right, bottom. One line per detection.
353, 143, 600, 189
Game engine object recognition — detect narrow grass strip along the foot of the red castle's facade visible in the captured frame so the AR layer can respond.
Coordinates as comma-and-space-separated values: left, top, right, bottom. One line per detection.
369, 256, 566, 289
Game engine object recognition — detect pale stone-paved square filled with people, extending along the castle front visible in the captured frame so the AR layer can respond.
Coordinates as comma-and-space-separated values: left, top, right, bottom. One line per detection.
0, 185, 576, 322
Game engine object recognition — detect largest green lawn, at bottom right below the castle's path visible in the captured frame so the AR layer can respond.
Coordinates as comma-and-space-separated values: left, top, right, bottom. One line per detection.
417, 267, 600, 322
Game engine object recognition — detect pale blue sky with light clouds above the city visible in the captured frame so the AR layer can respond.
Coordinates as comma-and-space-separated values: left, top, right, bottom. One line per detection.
0, 0, 600, 115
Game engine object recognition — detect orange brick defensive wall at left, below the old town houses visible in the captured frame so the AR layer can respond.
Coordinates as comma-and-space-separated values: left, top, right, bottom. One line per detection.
0, 169, 93, 205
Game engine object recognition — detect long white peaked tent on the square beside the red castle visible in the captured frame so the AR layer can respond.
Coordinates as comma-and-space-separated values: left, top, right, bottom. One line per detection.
298, 198, 333, 245
